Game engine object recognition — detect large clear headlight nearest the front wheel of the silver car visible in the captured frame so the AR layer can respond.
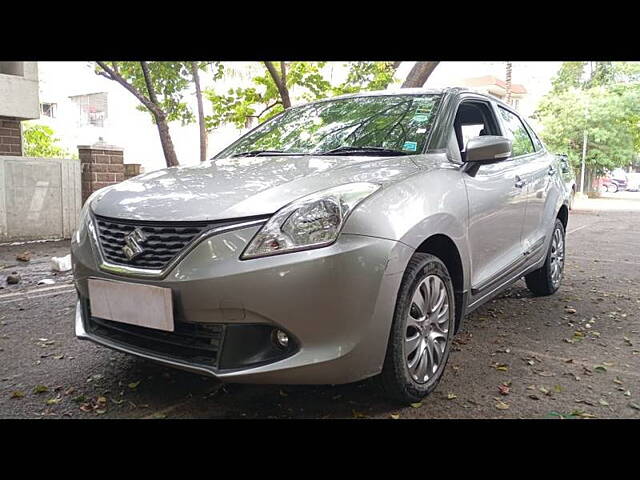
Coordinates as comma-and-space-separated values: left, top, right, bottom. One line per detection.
240, 183, 380, 260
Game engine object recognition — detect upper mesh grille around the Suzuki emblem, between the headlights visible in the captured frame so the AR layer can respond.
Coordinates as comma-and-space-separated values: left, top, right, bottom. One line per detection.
95, 216, 220, 270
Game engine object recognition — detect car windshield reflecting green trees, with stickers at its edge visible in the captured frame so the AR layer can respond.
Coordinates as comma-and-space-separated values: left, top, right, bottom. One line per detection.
216, 94, 440, 158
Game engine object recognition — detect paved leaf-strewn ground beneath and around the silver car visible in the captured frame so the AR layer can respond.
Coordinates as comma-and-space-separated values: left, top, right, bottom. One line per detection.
0, 193, 640, 418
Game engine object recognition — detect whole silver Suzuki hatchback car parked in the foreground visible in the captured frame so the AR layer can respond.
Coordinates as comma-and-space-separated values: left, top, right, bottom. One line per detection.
72, 88, 569, 402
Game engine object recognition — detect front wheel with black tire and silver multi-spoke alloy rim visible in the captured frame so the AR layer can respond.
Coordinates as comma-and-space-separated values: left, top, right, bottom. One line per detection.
380, 253, 455, 403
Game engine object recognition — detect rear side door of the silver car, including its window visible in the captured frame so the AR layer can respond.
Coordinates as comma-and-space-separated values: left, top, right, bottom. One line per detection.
498, 105, 556, 259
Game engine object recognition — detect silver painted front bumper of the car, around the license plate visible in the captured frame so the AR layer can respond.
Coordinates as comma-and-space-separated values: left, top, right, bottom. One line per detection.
72, 226, 413, 384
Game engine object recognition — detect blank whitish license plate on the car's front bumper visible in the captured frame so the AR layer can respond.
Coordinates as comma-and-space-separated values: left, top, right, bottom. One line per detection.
89, 278, 174, 332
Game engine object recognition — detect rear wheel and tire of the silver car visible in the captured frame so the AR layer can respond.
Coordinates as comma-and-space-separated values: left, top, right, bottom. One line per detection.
524, 218, 565, 296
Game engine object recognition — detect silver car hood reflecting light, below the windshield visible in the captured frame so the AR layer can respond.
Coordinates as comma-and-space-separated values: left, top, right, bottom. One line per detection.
91, 156, 428, 221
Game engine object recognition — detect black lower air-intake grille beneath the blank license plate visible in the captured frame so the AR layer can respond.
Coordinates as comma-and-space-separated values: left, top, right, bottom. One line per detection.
86, 308, 224, 368
